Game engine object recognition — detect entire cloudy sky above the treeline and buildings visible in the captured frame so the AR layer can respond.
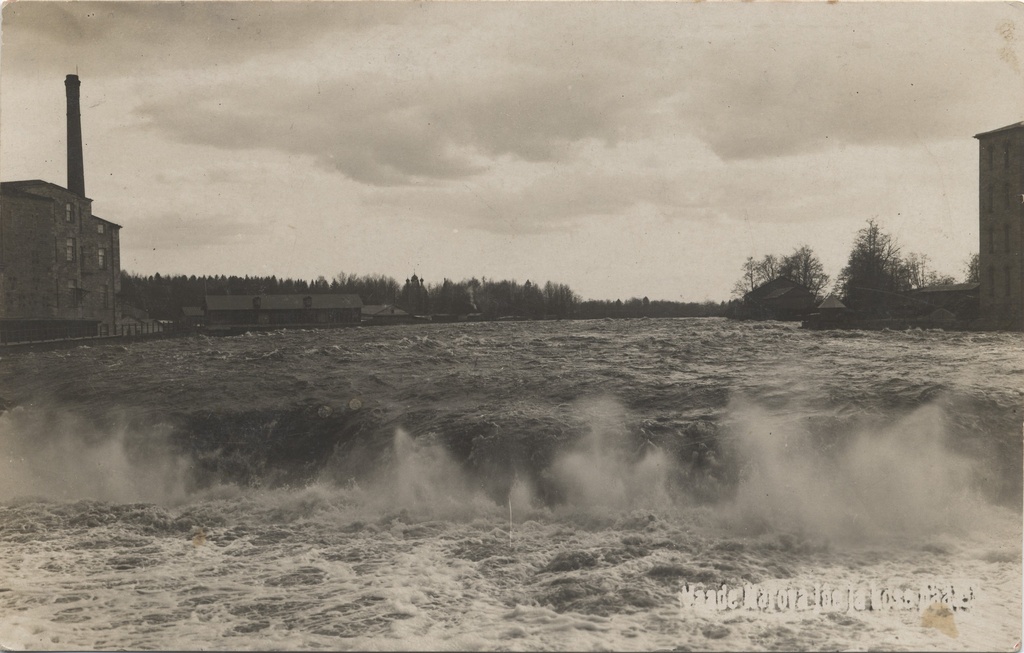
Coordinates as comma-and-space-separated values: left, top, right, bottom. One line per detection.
0, 0, 1024, 301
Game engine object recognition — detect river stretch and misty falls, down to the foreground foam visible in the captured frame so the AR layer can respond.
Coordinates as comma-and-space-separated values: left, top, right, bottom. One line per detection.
0, 320, 1022, 537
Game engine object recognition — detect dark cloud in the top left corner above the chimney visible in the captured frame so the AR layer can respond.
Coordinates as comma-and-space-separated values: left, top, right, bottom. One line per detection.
3, 0, 410, 78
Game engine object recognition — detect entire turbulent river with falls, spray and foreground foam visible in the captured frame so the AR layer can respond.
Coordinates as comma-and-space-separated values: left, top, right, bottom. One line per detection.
0, 319, 1024, 650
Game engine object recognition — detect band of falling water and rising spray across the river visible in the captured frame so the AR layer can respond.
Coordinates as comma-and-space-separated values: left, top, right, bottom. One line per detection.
0, 386, 1021, 540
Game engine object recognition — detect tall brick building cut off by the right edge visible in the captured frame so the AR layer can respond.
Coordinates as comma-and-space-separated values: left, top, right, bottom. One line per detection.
975, 123, 1024, 331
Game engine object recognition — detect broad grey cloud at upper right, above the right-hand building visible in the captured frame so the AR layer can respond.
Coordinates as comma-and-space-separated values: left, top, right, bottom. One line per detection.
674, 3, 1024, 161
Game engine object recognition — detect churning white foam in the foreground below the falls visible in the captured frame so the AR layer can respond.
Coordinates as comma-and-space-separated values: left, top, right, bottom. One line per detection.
0, 487, 1020, 650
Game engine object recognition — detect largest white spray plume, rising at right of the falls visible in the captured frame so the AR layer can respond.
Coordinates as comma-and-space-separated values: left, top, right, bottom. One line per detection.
733, 404, 985, 540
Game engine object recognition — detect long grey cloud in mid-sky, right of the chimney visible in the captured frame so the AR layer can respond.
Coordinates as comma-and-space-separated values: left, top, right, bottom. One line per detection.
136, 63, 638, 186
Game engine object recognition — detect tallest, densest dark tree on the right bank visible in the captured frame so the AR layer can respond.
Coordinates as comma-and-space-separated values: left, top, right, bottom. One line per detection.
837, 220, 906, 312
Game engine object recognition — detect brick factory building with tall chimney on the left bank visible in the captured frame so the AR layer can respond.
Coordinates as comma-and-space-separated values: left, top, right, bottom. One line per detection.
0, 75, 121, 341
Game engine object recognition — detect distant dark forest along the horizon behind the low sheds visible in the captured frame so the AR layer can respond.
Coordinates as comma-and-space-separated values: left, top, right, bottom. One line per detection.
120, 271, 728, 320
